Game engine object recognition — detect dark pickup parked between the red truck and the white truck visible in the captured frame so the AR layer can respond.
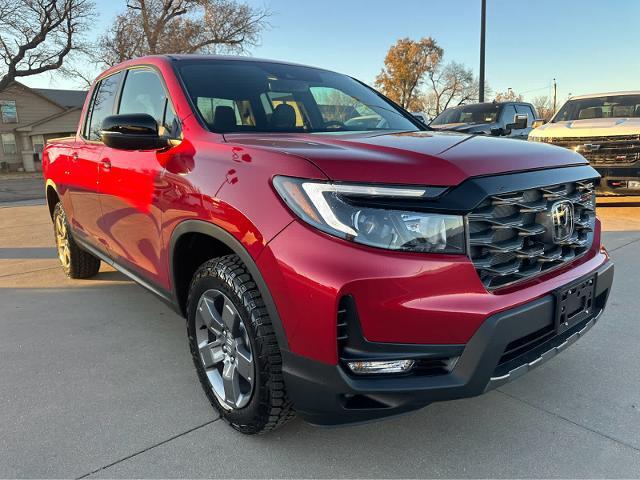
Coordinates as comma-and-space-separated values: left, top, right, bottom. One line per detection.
429, 102, 537, 140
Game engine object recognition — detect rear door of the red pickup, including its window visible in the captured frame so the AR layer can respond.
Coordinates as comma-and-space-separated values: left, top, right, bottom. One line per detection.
69, 72, 123, 250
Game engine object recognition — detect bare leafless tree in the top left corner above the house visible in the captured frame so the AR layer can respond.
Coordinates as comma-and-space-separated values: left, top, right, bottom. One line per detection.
0, 0, 94, 90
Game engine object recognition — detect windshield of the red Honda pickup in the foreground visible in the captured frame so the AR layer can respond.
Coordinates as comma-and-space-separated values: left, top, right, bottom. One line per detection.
179, 60, 421, 133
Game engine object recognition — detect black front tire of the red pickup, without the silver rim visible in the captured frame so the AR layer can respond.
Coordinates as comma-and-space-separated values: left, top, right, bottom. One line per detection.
187, 255, 295, 434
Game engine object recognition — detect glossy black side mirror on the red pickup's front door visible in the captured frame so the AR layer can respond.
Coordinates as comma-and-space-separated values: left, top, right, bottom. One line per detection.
100, 113, 169, 150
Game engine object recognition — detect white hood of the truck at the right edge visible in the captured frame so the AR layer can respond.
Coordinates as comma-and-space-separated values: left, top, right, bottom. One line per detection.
530, 118, 640, 138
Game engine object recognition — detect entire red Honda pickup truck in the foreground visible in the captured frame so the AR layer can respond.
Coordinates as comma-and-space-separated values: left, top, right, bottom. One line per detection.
43, 55, 613, 433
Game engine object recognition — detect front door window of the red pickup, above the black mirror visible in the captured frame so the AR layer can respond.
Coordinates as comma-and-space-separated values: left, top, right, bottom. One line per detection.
118, 68, 180, 138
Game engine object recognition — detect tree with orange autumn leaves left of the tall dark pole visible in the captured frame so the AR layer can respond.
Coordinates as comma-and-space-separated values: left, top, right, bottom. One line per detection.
376, 37, 443, 109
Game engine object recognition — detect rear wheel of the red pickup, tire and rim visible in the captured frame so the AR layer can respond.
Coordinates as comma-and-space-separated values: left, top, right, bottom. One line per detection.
53, 202, 100, 278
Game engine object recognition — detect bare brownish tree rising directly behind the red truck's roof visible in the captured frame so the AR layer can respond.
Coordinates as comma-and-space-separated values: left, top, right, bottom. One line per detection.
99, 0, 270, 65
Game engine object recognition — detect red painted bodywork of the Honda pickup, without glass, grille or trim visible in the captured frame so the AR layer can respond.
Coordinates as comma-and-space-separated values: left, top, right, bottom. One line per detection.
43, 57, 607, 372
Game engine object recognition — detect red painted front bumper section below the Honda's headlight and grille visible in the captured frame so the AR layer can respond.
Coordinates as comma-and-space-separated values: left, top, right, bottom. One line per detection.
258, 218, 608, 363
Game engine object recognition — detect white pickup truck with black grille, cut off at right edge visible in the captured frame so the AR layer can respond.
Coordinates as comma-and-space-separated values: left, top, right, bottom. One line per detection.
529, 91, 640, 195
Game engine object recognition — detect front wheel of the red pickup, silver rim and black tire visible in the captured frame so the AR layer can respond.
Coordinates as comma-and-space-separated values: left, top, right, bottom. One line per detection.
187, 255, 294, 434
